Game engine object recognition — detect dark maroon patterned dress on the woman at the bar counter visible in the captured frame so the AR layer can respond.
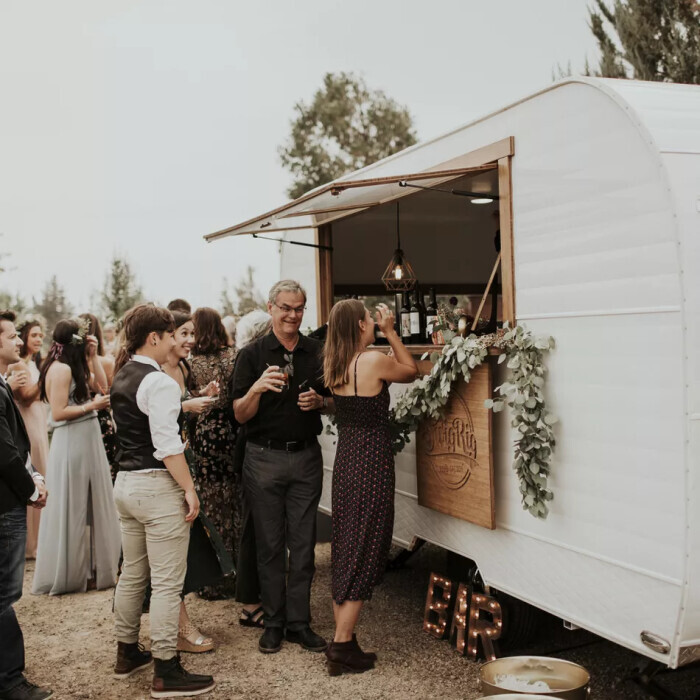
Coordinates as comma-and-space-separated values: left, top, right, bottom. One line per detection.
331, 356, 395, 605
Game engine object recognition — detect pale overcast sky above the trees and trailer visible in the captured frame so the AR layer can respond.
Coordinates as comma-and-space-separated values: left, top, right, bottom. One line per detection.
0, 0, 596, 311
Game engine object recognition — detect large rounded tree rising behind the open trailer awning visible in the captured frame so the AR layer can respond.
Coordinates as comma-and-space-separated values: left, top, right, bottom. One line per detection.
279, 73, 416, 199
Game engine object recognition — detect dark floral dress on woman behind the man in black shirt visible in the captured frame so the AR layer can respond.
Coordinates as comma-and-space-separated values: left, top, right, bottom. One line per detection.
190, 348, 242, 598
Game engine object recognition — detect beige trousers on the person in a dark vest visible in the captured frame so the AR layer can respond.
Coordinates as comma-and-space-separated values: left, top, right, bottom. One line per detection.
114, 469, 190, 660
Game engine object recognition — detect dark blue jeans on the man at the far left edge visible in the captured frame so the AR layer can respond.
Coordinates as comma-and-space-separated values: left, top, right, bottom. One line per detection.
0, 506, 27, 692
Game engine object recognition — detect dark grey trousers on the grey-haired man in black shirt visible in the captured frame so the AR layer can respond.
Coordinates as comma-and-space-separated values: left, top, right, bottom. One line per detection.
243, 442, 323, 630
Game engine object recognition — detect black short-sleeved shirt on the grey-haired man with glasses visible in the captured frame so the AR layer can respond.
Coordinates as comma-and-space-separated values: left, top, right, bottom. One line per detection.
232, 332, 331, 442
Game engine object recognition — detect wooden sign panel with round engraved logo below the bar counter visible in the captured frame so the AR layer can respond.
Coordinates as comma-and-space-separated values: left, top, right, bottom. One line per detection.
416, 362, 496, 530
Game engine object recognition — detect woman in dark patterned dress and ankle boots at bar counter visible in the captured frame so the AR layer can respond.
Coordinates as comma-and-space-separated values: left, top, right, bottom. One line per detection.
324, 299, 418, 675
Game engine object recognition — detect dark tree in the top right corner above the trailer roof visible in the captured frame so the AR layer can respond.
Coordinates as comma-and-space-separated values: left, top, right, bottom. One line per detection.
589, 0, 700, 84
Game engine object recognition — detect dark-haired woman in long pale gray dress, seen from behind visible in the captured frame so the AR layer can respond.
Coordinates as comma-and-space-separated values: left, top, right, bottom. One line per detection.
32, 320, 121, 595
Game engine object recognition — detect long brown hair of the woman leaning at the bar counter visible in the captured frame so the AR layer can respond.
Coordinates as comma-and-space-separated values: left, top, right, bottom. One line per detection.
323, 299, 367, 389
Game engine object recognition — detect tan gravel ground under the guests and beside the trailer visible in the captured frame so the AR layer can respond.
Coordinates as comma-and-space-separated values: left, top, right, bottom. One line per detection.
16, 543, 700, 700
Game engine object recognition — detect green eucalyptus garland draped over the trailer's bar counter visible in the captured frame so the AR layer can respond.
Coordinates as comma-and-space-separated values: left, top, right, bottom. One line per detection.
326, 326, 557, 518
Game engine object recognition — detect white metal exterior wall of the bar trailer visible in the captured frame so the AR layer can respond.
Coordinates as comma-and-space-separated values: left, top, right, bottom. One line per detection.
278, 81, 700, 665
